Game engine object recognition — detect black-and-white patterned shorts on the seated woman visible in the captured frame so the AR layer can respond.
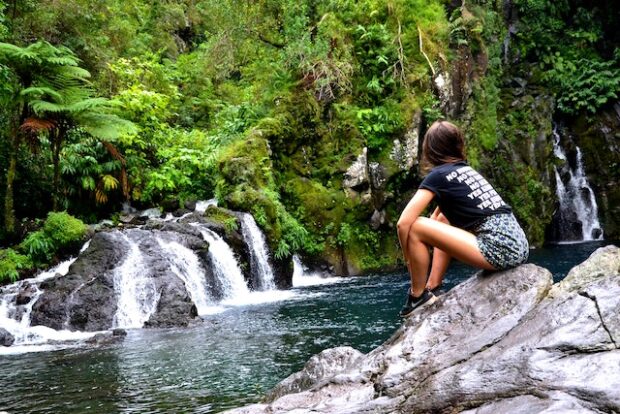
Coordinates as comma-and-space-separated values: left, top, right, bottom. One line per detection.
471, 213, 530, 270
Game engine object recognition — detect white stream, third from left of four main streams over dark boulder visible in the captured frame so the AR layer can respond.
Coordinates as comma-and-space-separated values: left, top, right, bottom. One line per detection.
200, 226, 250, 300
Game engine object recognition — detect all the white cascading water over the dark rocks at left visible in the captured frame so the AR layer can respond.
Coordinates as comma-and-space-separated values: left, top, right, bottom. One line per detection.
0, 210, 314, 353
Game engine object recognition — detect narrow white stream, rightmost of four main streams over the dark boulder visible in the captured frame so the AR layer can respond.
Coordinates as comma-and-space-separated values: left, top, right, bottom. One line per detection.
241, 213, 276, 290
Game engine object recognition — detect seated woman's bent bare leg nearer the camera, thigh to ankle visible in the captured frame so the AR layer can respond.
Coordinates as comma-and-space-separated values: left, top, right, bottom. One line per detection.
407, 217, 494, 296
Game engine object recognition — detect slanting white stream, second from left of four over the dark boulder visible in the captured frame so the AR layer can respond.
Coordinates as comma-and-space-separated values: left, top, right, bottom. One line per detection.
157, 237, 214, 315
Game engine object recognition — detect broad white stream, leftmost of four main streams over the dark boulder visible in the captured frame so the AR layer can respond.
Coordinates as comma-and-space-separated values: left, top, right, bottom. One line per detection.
112, 233, 160, 328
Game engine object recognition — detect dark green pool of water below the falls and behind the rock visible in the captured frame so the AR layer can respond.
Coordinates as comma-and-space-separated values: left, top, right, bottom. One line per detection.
0, 242, 606, 414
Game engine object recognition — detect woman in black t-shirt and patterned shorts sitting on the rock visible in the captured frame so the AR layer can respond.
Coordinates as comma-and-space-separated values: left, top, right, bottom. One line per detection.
398, 121, 529, 317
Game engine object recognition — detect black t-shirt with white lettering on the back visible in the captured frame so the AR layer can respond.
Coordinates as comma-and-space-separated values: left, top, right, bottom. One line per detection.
420, 161, 512, 229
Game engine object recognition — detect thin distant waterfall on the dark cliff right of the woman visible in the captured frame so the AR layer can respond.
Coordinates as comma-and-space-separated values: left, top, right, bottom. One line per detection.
553, 128, 603, 242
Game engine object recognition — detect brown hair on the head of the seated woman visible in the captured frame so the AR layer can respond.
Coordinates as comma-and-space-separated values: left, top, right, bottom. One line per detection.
422, 121, 466, 168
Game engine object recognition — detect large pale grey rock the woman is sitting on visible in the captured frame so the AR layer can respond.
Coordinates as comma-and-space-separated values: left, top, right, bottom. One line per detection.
227, 246, 620, 414
